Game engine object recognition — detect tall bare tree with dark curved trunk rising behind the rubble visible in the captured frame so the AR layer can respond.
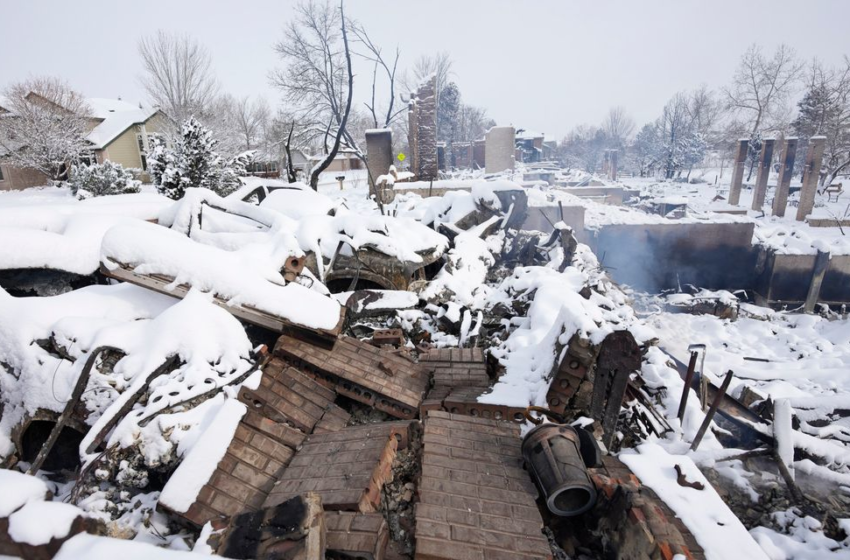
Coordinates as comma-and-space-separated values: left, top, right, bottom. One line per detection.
271, 0, 354, 189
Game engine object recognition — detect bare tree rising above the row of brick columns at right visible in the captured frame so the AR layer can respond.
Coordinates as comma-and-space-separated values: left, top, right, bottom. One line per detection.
724, 45, 803, 136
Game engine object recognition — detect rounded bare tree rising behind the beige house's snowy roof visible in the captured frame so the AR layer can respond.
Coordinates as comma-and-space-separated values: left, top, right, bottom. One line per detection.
139, 30, 218, 123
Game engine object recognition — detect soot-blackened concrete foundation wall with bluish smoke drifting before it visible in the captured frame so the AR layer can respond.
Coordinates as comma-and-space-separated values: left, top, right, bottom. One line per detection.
589, 223, 758, 292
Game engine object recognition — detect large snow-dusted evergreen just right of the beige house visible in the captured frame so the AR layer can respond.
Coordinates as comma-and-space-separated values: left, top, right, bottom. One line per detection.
151, 117, 252, 200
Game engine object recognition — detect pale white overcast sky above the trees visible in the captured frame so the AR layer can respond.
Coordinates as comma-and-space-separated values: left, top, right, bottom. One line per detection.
0, 0, 850, 138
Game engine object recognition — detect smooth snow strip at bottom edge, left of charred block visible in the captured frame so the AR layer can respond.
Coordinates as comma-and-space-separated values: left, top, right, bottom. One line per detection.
53, 533, 209, 560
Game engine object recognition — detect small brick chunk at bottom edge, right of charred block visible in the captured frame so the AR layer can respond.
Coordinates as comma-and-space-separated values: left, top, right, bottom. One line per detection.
325, 511, 389, 560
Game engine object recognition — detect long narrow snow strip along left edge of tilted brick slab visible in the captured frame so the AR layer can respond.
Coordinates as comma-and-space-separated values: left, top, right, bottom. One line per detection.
159, 399, 248, 512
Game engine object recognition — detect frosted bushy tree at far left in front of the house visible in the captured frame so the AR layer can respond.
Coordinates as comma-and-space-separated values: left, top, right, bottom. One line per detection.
0, 77, 91, 180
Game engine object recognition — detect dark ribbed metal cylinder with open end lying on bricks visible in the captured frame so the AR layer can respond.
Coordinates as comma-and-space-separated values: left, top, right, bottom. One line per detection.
522, 424, 596, 517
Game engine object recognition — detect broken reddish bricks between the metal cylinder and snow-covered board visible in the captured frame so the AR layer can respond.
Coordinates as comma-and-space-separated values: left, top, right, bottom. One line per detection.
588, 456, 705, 560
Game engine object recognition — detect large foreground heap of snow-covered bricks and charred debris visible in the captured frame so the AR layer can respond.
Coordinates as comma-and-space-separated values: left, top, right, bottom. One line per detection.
0, 175, 844, 560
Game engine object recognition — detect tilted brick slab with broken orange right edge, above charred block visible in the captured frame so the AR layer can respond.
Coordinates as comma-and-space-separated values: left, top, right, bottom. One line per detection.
263, 421, 410, 513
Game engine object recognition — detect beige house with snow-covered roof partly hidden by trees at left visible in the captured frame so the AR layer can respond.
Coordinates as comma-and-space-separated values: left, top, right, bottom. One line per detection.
0, 93, 171, 190
